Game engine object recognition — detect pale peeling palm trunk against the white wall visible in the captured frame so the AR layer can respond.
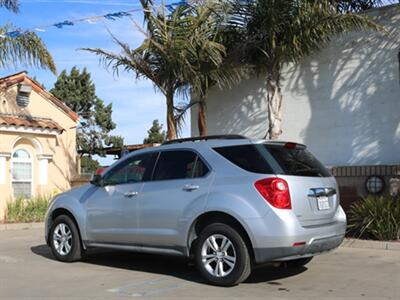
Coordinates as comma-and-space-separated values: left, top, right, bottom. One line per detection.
265, 79, 283, 140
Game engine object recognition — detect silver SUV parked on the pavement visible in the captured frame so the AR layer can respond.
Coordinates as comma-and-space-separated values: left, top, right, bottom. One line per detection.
45, 136, 346, 286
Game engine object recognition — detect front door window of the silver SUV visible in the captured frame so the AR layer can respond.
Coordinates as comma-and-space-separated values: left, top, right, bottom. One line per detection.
105, 153, 156, 185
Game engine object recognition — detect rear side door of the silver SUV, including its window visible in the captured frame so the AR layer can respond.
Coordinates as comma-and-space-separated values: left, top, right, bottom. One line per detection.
138, 150, 212, 247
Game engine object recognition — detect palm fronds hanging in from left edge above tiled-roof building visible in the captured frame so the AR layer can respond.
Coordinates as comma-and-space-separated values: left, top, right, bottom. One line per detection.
0, 0, 56, 73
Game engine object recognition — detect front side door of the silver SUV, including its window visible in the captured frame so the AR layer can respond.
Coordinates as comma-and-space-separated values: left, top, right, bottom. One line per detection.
86, 153, 156, 244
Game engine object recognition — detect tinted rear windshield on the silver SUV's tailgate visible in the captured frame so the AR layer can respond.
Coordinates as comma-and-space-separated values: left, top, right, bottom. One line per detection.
263, 145, 331, 177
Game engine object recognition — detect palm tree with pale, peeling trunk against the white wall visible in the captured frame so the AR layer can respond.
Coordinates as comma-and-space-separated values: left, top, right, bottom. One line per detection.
231, 0, 383, 139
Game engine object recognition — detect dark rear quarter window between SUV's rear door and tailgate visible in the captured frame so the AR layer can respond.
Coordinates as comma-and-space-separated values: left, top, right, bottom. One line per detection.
214, 145, 273, 174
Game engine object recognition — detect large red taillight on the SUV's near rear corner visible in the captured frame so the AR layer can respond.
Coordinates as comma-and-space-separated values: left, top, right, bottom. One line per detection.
254, 178, 292, 209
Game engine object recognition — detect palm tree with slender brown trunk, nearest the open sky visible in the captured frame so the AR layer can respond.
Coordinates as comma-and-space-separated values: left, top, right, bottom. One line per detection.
83, 0, 190, 139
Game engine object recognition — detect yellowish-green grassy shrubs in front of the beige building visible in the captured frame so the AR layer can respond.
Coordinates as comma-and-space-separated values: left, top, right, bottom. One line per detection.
6, 196, 51, 223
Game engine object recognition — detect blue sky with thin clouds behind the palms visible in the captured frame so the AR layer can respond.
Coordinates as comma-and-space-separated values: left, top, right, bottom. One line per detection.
0, 0, 190, 162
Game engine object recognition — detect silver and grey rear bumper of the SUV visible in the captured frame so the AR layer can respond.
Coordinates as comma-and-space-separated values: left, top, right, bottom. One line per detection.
246, 206, 347, 263
